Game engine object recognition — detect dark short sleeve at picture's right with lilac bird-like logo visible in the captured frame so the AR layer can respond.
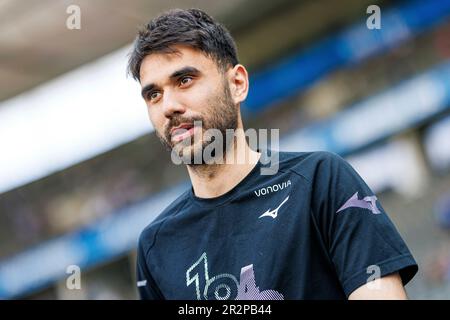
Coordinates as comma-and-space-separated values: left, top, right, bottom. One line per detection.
312, 152, 418, 297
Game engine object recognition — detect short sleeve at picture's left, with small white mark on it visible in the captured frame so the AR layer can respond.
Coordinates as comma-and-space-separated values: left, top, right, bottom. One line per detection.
136, 236, 164, 300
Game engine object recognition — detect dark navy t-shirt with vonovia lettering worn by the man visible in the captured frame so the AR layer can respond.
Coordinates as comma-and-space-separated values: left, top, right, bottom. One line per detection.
137, 151, 418, 300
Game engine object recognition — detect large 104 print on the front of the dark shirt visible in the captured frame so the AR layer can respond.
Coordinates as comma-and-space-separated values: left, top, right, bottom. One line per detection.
186, 252, 284, 300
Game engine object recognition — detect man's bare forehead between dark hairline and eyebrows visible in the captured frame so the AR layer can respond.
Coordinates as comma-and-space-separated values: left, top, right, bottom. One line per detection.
140, 46, 218, 86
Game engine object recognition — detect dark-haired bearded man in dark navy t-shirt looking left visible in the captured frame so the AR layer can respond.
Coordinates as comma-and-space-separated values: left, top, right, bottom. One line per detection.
129, 9, 418, 300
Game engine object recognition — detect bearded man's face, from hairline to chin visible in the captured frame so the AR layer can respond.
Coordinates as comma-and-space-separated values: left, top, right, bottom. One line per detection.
140, 46, 238, 163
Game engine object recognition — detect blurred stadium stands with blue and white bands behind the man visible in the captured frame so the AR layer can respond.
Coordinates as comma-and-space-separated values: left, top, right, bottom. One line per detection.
0, 0, 450, 299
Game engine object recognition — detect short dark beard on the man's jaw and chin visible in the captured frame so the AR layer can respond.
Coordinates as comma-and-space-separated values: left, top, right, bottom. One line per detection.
156, 81, 238, 166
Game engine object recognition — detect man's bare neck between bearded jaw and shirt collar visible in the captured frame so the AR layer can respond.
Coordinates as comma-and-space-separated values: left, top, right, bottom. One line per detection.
187, 130, 261, 198
